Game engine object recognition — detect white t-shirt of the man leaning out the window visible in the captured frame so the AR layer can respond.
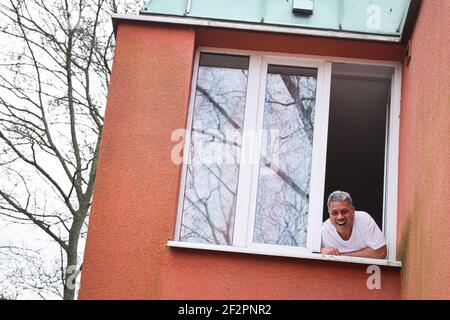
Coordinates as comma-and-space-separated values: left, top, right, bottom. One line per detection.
322, 211, 386, 253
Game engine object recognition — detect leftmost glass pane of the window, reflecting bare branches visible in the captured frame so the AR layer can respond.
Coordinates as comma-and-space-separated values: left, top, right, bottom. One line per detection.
180, 54, 249, 245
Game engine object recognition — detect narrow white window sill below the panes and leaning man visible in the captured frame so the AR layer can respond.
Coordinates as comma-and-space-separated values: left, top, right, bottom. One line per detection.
167, 240, 402, 267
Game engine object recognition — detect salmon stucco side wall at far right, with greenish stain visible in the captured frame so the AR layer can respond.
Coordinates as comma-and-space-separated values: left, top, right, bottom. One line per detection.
398, 0, 450, 299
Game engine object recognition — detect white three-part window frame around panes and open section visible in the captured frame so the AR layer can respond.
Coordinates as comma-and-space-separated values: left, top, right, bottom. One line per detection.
168, 47, 402, 267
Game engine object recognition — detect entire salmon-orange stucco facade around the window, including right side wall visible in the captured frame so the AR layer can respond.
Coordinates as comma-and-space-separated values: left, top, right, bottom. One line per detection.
79, 1, 450, 299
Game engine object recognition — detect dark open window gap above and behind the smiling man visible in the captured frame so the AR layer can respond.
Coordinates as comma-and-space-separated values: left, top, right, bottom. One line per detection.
324, 63, 394, 230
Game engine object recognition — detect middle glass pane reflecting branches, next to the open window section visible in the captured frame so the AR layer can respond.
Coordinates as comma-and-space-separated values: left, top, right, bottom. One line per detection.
254, 66, 317, 246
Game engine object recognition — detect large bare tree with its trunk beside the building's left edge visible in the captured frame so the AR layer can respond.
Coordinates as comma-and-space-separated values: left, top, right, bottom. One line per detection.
0, 0, 142, 299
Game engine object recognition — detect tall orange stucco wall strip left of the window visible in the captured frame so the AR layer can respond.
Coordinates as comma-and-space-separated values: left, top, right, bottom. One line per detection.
79, 25, 195, 299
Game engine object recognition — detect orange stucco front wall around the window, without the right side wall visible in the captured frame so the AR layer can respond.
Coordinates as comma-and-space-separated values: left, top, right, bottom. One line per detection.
75, 22, 402, 299
